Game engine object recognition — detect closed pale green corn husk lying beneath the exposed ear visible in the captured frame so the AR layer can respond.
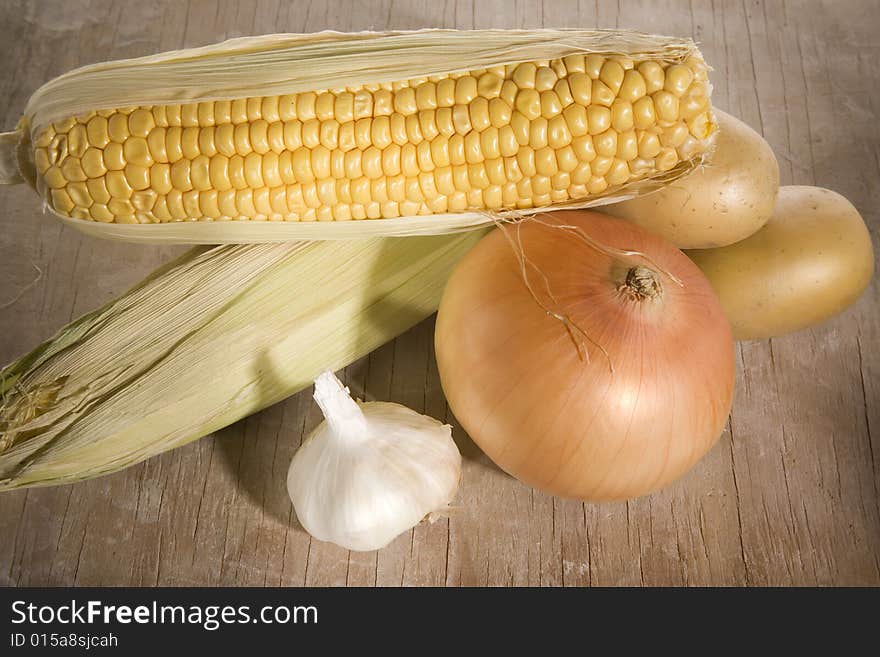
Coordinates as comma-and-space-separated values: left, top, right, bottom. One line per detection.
0, 230, 485, 490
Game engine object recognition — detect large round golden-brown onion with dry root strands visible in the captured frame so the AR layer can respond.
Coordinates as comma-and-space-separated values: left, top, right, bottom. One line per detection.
435, 211, 734, 501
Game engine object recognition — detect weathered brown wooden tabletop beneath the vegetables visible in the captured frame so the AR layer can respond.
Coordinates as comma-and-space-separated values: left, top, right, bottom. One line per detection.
0, 0, 880, 586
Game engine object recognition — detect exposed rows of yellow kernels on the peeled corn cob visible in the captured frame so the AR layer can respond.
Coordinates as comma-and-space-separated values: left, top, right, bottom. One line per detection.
0, 31, 716, 239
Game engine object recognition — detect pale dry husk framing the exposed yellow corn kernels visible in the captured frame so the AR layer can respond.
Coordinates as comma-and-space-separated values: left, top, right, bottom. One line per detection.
0, 29, 711, 244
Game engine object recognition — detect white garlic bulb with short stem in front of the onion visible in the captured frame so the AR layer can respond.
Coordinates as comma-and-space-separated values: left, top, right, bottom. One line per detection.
287, 372, 461, 551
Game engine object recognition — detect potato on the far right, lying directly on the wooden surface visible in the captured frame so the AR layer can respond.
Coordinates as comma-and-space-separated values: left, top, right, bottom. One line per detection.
687, 187, 874, 340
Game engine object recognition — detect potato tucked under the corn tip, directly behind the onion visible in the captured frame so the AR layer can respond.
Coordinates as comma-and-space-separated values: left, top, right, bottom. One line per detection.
597, 109, 779, 249
